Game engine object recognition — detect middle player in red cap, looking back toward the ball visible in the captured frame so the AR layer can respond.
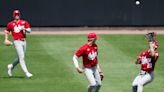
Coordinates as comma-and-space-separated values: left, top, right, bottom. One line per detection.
73, 32, 104, 92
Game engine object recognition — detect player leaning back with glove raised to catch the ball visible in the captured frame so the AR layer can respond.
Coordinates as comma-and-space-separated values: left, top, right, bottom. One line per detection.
132, 32, 159, 92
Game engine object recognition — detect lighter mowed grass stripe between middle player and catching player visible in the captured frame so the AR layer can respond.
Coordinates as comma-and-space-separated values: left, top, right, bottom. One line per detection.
98, 36, 136, 92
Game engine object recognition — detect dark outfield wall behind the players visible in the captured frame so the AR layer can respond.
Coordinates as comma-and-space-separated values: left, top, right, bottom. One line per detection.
0, 0, 164, 26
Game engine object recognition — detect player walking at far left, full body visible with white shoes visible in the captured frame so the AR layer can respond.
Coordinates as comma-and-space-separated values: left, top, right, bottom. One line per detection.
4, 10, 33, 78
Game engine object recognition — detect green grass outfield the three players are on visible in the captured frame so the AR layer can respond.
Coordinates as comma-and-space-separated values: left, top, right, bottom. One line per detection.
0, 35, 164, 92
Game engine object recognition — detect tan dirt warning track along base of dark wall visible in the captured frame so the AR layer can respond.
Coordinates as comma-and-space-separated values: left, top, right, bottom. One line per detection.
0, 27, 164, 35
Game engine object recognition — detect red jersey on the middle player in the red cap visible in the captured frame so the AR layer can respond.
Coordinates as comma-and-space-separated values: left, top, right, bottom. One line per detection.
75, 44, 98, 67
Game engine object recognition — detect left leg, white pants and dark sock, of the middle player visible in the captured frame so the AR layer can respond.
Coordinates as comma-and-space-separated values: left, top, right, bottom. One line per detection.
84, 68, 96, 92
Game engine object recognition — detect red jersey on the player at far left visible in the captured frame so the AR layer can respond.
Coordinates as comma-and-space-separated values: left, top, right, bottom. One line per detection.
5, 20, 30, 40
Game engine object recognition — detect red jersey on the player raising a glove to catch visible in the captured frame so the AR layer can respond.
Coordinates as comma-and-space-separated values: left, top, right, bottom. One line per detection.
138, 50, 159, 72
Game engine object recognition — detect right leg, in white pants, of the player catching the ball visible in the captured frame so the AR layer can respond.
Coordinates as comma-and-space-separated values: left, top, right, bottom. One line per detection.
137, 73, 154, 92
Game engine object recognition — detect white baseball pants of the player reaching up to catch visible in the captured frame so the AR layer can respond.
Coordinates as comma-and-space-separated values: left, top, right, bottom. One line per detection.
132, 71, 154, 92
